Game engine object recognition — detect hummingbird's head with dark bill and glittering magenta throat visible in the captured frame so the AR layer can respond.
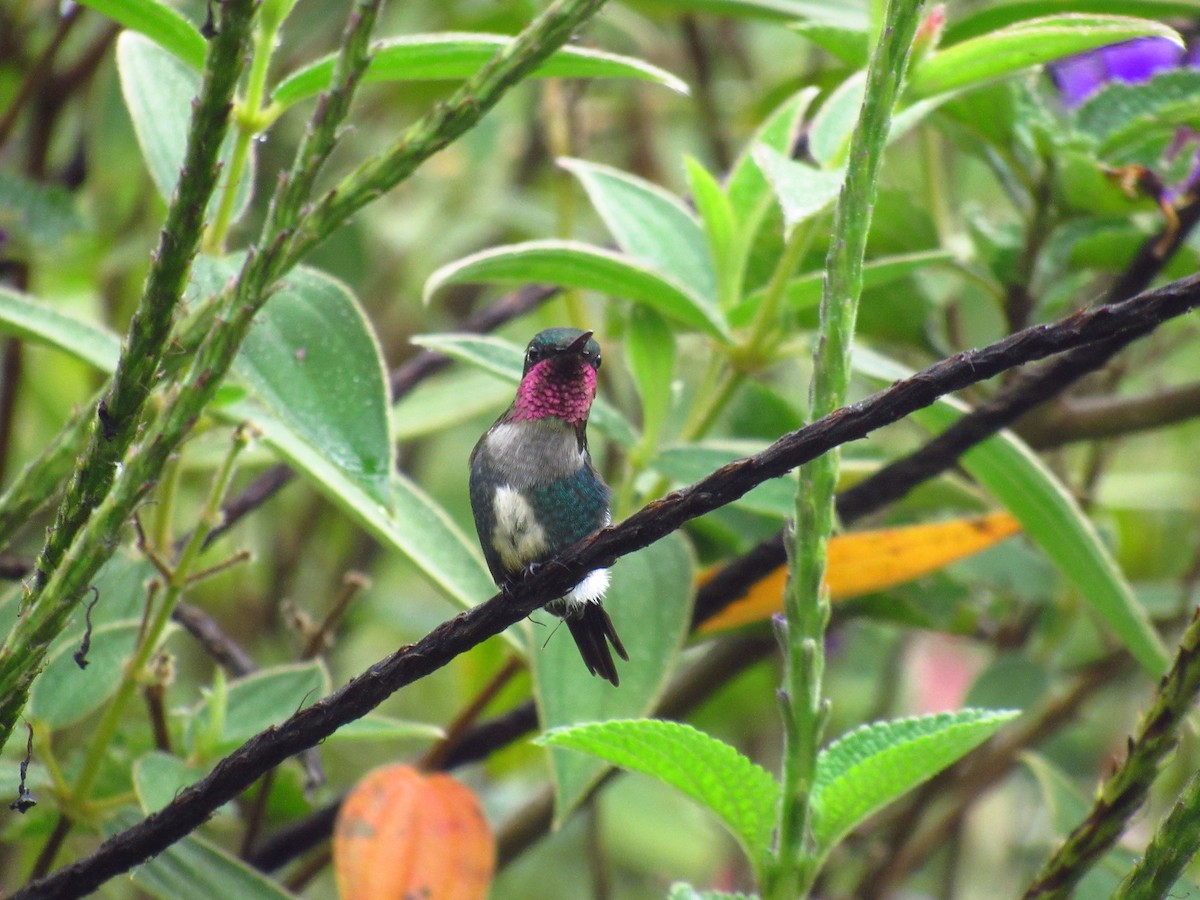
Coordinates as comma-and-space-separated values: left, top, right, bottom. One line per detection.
510, 328, 600, 426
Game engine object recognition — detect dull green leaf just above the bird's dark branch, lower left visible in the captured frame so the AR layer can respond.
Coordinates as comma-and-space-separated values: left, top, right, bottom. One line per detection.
188, 660, 331, 754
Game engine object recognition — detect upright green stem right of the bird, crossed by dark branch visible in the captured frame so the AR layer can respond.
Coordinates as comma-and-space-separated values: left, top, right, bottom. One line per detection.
763, 0, 922, 900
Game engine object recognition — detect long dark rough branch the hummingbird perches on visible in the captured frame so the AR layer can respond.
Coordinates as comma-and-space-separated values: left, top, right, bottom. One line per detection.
13, 276, 1200, 900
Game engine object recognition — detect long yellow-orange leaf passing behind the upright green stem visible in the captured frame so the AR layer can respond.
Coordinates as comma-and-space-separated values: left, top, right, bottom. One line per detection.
700, 512, 1021, 634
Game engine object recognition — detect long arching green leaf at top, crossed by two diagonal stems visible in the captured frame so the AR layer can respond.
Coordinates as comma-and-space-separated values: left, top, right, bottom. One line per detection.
272, 34, 688, 107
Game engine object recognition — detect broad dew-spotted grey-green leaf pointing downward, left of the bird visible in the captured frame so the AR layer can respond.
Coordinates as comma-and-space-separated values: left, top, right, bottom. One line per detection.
193, 258, 395, 509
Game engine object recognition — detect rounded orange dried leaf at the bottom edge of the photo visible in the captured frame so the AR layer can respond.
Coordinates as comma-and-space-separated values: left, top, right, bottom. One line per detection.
334, 764, 496, 900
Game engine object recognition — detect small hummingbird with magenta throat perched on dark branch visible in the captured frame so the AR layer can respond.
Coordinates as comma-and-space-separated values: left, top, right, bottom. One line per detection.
470, 328, 629, 686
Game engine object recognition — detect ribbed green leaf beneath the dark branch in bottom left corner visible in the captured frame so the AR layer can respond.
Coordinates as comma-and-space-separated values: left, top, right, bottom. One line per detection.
104, 811, 294, 900
